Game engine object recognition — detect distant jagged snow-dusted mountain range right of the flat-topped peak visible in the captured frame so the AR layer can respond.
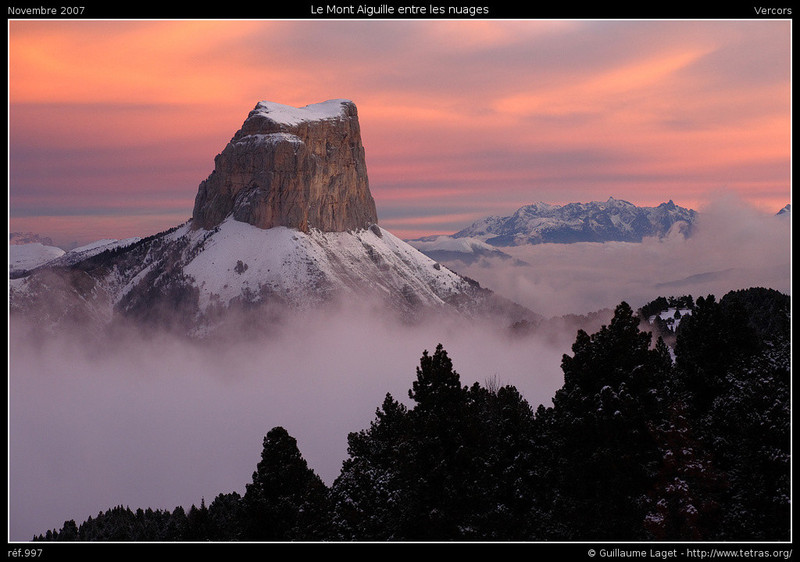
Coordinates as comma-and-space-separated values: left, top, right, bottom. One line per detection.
446, 197, 696, 247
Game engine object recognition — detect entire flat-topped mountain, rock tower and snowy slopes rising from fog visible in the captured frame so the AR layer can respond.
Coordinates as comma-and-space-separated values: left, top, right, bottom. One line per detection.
10, 100, 536, 337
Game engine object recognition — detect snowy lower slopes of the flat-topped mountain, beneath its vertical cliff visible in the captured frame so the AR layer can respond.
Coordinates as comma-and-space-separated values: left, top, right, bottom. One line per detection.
10, 218, 533, 337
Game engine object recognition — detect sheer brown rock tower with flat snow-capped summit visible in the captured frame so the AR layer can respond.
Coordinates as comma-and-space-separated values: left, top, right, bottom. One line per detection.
192, 100, 378, 232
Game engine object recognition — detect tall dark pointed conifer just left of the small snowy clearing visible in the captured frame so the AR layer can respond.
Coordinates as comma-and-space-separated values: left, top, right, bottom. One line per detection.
547, 302, 672, 540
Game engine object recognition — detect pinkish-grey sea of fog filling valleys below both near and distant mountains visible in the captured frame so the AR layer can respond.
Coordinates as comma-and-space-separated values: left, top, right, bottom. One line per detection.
8, 196, 790, 541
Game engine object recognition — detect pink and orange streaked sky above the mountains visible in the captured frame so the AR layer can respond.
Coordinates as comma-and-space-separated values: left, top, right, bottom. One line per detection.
9, 20, 791, 244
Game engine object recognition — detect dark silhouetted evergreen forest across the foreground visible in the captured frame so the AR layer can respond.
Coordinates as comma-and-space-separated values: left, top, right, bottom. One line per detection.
34, 288, 791, 542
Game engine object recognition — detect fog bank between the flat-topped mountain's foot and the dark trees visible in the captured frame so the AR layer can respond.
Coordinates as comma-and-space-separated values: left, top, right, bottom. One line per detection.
9, 313, 574, 540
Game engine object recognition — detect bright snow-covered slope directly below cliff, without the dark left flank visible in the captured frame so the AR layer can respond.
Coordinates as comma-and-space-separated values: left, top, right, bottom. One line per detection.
180, 218, 466, 309
